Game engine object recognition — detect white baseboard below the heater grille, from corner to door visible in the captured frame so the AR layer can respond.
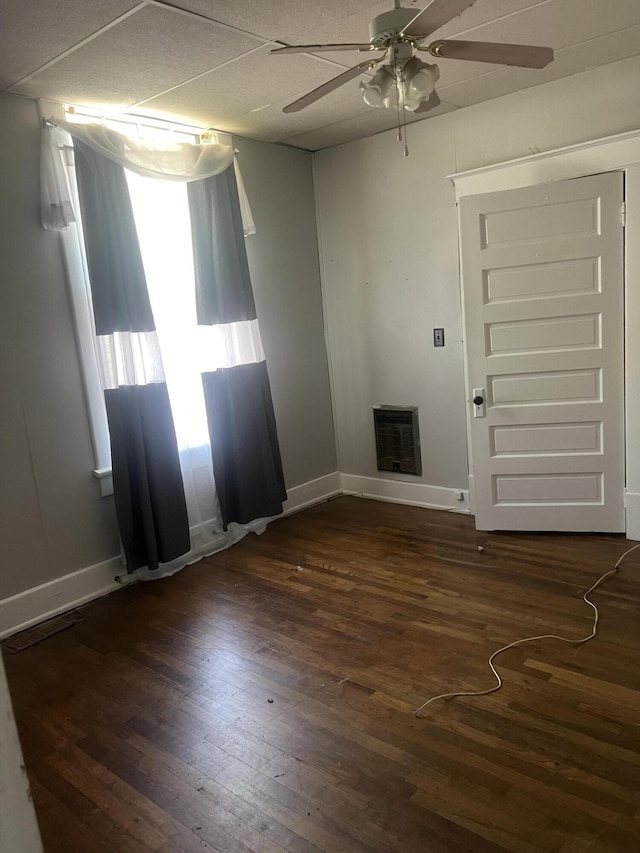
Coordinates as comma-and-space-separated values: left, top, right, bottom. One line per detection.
341, 474, 470, 514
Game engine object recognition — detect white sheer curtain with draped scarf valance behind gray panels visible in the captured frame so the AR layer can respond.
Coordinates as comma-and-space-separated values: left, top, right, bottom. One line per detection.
41, 119, 267, 580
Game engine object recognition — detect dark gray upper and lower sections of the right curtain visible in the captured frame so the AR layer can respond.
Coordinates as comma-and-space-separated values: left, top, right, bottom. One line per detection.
188, 161, 287, 530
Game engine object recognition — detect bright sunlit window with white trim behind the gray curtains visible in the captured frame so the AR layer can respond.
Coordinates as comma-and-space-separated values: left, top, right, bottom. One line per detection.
55, 108, 255, 495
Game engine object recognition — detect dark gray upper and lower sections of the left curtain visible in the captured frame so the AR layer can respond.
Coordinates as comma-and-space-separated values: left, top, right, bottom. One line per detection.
75, 136, 190, 572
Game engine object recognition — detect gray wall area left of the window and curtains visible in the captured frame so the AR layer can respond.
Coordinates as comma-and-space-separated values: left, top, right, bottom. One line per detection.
0, 95, 119, 598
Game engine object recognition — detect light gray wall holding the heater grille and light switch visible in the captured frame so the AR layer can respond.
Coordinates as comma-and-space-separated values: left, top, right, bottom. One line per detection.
314, 57, 640, 488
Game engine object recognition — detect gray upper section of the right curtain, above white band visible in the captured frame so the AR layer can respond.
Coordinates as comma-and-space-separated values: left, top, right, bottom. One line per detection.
187, 166, 256, 326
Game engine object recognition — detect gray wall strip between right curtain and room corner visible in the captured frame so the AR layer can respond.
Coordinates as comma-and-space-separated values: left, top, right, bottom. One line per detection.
234, 138, 337, 487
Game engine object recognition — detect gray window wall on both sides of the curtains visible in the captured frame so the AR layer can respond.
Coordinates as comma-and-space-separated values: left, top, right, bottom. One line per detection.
0, 95, 336, 599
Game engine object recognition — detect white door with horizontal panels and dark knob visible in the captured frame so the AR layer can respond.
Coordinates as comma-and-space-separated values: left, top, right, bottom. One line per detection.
460, 172, 625, 532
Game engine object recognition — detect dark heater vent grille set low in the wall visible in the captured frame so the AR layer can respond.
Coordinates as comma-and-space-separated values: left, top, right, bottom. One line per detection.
373, 406, 422, 476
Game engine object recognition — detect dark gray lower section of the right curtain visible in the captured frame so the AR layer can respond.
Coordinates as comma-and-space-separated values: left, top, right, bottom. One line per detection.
202, 361, 287, 530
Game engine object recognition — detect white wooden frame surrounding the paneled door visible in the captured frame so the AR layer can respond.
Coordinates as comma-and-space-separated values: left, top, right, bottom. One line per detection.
448, 125, 640, 540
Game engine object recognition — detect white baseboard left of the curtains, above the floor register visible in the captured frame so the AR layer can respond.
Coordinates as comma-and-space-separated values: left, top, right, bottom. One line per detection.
0, 556, 127, 639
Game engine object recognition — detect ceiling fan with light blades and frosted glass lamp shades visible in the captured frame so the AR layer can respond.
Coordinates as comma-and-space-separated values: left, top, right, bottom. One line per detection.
270, 0, 553, 116
